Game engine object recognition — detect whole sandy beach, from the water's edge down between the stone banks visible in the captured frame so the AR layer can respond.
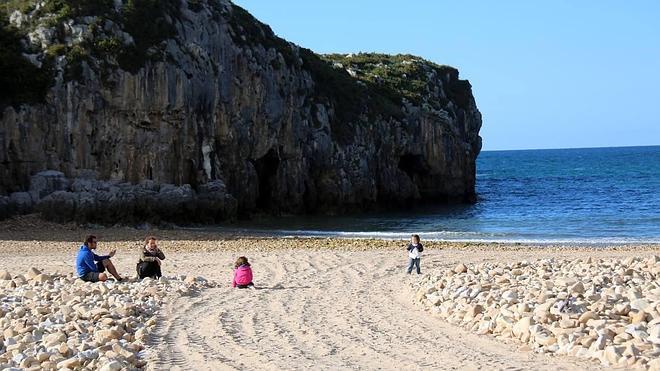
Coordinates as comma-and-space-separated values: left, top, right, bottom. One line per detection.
0, 218, 660, 370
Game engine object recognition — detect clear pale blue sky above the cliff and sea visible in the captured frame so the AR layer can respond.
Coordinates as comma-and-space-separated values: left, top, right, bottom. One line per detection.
236, 0, 660, 150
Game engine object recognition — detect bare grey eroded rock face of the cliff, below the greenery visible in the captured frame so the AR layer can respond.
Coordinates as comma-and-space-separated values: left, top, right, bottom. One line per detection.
0, 2, 481, 222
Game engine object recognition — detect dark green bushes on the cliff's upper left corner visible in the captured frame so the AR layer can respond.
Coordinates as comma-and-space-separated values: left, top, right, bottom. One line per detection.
0, 0, 179, 89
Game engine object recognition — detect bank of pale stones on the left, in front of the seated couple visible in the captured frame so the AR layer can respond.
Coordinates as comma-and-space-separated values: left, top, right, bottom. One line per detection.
0, 268, 216, 370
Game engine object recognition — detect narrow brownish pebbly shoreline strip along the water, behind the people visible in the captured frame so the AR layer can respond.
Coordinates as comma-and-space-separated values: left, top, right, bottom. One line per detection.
0, 214, 660, 252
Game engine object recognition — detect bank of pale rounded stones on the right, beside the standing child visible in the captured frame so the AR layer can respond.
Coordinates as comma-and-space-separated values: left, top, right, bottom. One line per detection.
415, 256, 660, 371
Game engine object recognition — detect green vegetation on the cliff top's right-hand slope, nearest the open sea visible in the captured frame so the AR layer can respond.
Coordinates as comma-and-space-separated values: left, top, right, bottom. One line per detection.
228, 5, 458, 129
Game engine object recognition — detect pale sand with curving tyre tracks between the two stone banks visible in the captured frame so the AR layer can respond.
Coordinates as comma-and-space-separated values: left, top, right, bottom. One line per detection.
151, 251, 598, 370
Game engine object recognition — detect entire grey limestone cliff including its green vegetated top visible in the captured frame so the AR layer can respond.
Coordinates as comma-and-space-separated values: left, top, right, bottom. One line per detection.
0, 0, 481, 223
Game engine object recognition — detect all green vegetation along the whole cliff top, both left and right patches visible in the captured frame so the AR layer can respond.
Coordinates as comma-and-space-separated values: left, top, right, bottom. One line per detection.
0, 0, 465, 125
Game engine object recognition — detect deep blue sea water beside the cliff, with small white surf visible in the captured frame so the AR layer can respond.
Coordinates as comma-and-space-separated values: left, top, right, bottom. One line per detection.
214, 146, 660, 244
